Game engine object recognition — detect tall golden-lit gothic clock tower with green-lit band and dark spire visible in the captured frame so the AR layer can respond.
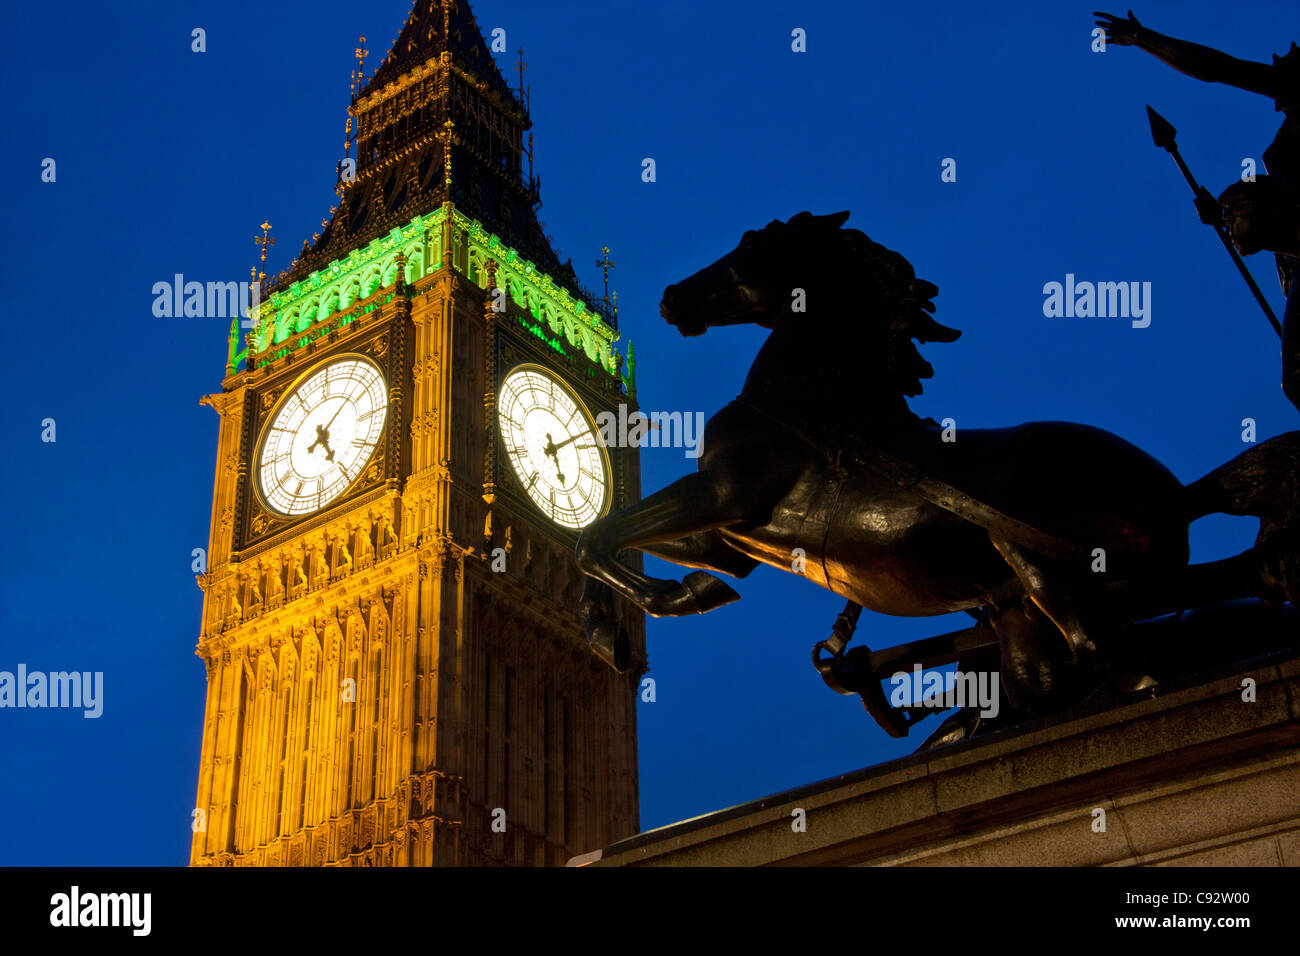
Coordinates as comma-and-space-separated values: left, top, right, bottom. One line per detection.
191, 0, 645, 866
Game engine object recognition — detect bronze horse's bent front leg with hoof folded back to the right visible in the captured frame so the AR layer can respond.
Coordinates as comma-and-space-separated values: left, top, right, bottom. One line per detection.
576, 471, 740, 618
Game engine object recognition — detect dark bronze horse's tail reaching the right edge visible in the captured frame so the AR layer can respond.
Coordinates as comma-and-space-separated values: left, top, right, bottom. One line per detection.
1186, 432, 1300, 525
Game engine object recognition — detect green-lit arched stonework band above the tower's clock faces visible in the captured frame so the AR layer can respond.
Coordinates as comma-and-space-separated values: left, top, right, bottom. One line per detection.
237, 203, 634, 388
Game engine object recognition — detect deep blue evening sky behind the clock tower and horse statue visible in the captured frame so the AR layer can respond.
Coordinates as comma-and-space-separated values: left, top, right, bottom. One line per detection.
0, 0, 1300, 865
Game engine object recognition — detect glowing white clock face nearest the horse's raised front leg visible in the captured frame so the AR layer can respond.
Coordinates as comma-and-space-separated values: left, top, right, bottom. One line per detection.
497, 365, 610, 528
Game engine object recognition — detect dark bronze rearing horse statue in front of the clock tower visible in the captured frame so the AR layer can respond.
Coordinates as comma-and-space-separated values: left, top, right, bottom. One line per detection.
576, 212, 1300, 733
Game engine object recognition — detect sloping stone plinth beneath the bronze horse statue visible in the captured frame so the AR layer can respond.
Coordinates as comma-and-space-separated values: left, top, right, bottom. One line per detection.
585, 650, 1300, 866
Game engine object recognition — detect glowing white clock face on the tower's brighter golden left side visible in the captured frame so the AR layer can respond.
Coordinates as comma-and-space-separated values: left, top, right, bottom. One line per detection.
256, 355, 389, 515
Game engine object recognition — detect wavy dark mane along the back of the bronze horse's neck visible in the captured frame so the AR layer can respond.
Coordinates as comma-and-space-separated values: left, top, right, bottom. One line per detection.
787, 212, 962, 395
